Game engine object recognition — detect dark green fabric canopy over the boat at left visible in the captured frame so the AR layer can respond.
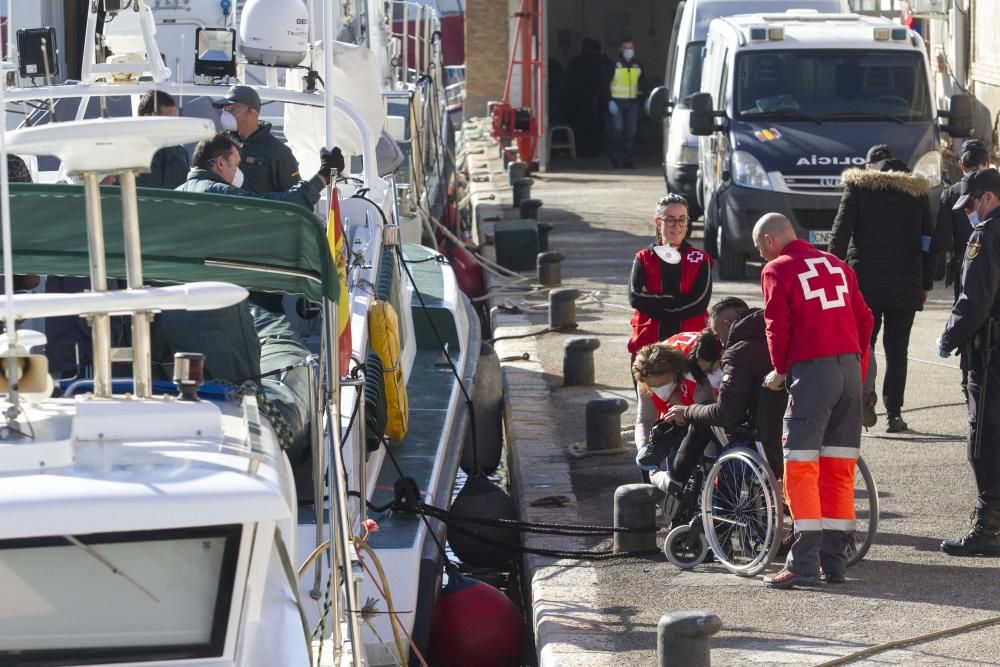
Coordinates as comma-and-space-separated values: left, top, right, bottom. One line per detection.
10, 183, 339, 301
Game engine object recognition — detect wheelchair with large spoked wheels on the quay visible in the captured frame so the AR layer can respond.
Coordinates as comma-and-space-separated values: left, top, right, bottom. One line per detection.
663, 428, 878, 577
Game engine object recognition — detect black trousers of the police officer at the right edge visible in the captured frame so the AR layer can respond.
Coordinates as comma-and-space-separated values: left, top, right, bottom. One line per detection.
962, 327, 1000, 510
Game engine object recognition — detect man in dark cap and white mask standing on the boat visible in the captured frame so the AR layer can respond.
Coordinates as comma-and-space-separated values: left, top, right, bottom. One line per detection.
212, 86, 301, 195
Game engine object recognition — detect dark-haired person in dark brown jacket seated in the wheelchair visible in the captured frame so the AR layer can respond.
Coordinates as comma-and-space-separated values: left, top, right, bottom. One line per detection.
654, 297, 788, 520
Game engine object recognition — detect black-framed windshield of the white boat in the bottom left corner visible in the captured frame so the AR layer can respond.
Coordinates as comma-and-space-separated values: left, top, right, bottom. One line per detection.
0, 525, 241, 666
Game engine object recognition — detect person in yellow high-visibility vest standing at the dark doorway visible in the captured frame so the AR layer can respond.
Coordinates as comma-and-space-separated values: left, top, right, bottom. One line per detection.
608, 37, 646, 169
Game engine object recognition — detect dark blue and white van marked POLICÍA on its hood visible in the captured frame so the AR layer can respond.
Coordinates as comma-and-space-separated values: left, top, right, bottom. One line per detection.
690, 12, 973, 279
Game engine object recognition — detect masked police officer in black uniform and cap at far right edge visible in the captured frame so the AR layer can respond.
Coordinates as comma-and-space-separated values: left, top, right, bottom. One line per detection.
937, 168, 1000, 556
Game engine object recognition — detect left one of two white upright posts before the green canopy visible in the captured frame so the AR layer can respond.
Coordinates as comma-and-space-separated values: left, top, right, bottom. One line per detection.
83, 171, 111, 398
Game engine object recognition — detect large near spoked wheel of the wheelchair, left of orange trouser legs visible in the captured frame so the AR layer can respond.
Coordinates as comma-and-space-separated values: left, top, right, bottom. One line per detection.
701, 447, 784, 577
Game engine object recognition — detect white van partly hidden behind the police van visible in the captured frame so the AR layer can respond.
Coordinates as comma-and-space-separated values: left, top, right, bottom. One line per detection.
647, 0, 850, 215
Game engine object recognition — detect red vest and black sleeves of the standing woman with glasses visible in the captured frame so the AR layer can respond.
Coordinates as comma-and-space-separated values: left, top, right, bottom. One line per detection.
628, 241, 712, 356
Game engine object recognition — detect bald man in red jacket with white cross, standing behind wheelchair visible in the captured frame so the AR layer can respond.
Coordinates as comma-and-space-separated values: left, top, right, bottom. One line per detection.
753, 213, 874, 588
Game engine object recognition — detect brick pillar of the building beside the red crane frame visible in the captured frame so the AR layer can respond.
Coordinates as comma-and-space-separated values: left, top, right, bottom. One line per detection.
465, 0, 510, 118
